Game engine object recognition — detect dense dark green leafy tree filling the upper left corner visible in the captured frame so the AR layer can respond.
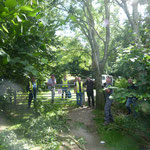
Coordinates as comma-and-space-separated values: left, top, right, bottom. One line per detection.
0, 0, 59, 85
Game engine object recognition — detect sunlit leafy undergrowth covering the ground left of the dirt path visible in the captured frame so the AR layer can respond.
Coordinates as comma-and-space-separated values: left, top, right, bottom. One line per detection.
0, 98, 80, 150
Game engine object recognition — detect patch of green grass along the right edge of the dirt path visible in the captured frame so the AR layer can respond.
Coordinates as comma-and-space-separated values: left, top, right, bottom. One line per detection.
94, 110, 141, 150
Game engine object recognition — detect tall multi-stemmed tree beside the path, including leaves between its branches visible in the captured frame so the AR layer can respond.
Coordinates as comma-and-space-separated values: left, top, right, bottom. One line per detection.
58, 0, 111, 109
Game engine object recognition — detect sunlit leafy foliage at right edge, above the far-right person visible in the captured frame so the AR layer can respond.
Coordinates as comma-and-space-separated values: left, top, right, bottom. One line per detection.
113, 46, 150, 92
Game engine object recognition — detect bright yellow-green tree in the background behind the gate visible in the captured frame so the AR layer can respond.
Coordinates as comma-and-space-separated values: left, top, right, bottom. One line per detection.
53, 36, 92, 79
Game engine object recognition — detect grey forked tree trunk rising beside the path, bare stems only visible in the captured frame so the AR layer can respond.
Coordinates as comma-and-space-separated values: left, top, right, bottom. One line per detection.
78, 0, 110, 110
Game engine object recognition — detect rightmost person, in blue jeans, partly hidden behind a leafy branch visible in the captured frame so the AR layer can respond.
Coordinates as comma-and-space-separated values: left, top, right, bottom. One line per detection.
126, 78, 137, 115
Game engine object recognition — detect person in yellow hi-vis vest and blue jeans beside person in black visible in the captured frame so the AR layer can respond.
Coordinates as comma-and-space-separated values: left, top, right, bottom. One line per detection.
75, 77, 84, 107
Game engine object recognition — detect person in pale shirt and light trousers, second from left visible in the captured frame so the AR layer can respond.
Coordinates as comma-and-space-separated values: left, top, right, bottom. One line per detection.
47, 74, 56, 103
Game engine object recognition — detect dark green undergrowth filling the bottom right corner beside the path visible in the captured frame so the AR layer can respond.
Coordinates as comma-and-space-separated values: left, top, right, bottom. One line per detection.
94, 110, 150, 150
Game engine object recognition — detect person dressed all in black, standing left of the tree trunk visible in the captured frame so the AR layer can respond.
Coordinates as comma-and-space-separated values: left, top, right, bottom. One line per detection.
84, 77, 94, 108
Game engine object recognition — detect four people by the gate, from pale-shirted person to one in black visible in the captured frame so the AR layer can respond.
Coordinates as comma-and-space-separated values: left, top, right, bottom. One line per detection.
47, 74, 94, 108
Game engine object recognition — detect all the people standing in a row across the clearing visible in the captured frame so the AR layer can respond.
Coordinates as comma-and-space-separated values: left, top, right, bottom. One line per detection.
28, 74, 136, 125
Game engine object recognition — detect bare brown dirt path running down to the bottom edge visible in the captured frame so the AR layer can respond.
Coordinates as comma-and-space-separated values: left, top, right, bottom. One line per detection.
69, 107, 106, 150
